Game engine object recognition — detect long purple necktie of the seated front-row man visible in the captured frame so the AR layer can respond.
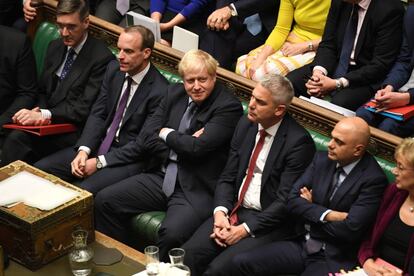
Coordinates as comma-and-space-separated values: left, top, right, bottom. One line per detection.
98, 76, 132, 155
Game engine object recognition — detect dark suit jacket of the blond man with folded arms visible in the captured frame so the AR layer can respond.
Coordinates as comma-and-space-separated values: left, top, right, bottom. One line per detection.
107, 82, 242, 218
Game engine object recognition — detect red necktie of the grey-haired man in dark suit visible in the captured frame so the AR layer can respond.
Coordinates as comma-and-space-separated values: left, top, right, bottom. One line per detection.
230, 129, 267, 225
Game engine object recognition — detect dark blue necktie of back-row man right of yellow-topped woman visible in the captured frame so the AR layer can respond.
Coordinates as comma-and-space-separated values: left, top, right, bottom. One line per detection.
333, 4, 359, 78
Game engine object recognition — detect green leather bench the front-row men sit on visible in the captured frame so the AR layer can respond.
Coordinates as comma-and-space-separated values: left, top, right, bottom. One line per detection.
33, 22, 395, 250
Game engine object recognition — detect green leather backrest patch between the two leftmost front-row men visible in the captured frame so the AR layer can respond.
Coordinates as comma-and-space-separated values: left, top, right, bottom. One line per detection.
33, 21, 60, 75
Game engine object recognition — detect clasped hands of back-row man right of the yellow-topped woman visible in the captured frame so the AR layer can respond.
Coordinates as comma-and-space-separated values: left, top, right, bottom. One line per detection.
305, 70, 336, 98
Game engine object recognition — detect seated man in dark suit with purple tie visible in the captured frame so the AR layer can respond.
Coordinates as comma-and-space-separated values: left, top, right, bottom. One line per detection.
35, 26, 168, 195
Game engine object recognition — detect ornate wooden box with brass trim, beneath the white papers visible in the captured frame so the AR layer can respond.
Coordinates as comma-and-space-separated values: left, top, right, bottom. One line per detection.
0, 161, 95, 270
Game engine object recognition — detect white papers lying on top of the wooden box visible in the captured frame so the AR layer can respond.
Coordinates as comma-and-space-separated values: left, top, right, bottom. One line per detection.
0, 171, 79, 211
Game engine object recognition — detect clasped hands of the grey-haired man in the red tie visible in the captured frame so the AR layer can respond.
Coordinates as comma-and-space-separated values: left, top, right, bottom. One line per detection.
210, 211, 249, 247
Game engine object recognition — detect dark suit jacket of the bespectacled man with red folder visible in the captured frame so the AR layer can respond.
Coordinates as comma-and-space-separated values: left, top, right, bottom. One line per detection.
39, 35, 115, 128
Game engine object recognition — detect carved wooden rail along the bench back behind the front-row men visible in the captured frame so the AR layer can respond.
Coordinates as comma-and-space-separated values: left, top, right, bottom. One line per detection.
28, 0, 401, 162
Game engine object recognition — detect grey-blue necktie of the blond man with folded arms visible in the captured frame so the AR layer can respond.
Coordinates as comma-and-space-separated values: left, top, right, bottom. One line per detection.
162, 101, 197, 197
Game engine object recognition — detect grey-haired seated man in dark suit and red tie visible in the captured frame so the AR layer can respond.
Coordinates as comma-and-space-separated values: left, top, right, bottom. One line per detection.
183, 76, 315, 276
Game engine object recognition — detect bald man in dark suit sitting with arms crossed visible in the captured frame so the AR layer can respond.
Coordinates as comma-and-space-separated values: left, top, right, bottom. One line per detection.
233, 117, 387, 276
